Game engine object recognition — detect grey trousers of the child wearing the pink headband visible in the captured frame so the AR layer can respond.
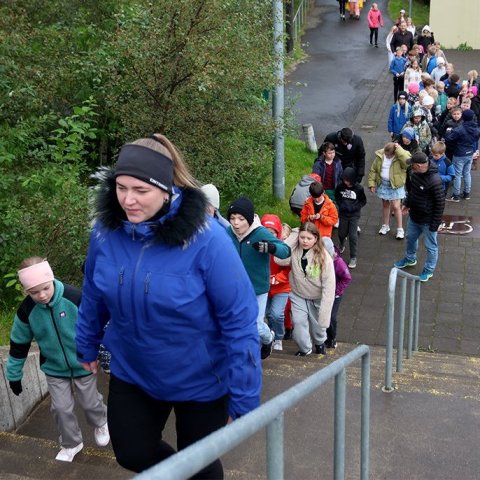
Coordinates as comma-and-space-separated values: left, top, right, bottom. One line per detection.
46, 375, 107, 448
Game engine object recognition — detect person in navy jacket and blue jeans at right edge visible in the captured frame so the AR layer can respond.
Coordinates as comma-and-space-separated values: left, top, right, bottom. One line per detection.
445, 109, 480, 202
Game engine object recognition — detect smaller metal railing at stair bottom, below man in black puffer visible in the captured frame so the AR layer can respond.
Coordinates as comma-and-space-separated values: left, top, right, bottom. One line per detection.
382, 268, 421, 393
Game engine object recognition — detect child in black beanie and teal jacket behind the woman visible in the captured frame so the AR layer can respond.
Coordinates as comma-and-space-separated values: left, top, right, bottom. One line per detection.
227, 196, 290, 360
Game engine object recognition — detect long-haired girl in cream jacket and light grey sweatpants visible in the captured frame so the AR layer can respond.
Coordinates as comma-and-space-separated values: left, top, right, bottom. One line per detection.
275, 222, 335, 357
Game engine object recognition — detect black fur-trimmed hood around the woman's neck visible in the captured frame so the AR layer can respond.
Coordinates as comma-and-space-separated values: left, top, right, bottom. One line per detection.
93, 168, 207, 245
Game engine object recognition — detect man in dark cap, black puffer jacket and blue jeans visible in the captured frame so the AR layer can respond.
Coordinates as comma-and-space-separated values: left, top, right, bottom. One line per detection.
394, 152, 445, 282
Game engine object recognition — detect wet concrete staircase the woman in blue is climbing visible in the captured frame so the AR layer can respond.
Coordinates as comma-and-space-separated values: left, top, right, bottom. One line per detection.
0, 341, 480, 480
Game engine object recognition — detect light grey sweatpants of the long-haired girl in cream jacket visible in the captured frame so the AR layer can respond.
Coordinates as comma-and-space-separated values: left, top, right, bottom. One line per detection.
290, 292, 327, 353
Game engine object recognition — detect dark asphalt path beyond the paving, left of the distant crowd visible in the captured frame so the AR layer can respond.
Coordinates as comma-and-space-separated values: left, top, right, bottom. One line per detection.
286, 0, 392, 139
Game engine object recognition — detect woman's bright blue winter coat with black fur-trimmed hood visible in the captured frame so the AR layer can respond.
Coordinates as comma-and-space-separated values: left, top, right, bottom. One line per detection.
77, 173, 262, 418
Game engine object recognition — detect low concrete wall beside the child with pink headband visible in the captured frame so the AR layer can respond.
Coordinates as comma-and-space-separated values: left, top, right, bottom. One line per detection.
0, 345, 48, 432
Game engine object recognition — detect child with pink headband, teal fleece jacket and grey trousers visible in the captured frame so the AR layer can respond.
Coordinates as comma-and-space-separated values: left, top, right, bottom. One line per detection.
6, 257, 110, 462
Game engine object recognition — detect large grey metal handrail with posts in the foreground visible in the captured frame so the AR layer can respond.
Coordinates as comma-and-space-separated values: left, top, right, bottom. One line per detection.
134, 345, 370, 480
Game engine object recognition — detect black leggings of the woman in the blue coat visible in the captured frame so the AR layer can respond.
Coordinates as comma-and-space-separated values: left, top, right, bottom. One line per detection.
108, 375, 228, 479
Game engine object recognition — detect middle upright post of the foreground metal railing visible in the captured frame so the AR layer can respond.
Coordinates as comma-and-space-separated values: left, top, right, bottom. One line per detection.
333, 369, 347, 480
